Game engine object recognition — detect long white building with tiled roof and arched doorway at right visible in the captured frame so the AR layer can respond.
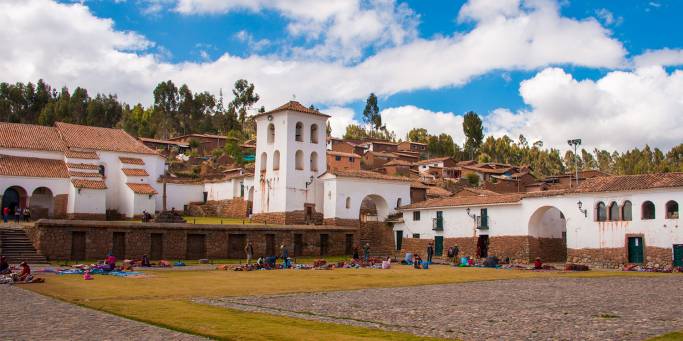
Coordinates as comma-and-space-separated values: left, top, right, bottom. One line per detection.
394, 173, 683, 268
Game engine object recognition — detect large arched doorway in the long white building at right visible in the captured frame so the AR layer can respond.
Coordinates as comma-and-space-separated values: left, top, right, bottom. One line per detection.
529, 206, 567, 262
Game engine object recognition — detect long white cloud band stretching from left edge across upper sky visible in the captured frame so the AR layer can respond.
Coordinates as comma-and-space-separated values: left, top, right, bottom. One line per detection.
0, 0, 625, 123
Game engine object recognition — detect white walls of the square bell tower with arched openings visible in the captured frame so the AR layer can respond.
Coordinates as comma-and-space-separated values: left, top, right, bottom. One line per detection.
254, 111, 327, 213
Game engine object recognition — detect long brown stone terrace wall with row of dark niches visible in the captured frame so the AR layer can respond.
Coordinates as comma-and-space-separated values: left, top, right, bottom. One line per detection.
27, 220, 359, 260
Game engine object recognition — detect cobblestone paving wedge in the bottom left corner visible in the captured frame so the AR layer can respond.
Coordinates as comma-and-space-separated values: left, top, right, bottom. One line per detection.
0, 284, 204, 341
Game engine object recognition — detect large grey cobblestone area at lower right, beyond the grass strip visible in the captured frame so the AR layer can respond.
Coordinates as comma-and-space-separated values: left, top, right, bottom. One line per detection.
197, 274, 683, 340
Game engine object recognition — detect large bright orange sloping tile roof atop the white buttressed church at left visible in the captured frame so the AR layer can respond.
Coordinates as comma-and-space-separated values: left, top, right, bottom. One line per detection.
55, 122, 156, 154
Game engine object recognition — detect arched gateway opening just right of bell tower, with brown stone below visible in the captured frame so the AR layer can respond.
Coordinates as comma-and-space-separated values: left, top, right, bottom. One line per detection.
358, 194, 394, 256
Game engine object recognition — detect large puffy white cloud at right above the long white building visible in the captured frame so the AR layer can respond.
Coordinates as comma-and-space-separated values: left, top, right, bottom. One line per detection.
485, 67, 683, 150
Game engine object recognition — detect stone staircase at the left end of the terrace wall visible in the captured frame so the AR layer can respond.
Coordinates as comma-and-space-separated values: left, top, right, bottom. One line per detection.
0, 226, 47, 264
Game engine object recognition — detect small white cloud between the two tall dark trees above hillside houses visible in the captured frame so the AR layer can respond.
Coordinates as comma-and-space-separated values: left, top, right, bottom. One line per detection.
380, 105, 465, 145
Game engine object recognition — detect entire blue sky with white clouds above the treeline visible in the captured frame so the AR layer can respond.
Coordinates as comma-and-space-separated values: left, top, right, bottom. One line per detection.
0, 0, 683, 151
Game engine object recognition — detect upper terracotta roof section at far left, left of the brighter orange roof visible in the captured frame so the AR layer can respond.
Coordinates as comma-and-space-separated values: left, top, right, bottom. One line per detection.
0, 122, 66, 151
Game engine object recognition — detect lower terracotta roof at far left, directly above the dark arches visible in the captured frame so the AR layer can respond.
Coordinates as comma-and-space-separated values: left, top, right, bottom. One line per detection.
0, 155, 69, 178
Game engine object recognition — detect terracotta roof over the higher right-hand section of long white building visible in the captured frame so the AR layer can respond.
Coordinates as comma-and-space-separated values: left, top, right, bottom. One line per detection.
573, 173, 683, 193
